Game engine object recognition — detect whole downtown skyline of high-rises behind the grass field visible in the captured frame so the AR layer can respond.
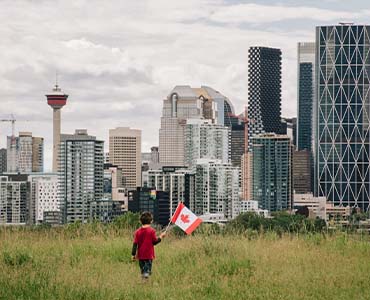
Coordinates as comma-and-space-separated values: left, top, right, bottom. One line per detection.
0, 24, 370, 226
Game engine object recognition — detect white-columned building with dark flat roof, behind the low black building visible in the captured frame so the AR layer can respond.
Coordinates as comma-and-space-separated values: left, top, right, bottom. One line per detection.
148, 166, 194, 215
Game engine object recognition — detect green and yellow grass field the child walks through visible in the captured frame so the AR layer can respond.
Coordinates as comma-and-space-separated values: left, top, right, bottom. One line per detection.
0, 226, 370, 300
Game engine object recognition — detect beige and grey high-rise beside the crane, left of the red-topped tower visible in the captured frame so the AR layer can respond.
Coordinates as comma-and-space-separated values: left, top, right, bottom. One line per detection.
7, 132, 44, 174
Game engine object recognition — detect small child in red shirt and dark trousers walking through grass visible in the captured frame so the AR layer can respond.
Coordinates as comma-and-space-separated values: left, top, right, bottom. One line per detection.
132, 212, 166, 279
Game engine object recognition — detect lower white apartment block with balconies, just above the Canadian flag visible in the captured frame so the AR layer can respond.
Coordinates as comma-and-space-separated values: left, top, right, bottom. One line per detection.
190, 159, 240, 219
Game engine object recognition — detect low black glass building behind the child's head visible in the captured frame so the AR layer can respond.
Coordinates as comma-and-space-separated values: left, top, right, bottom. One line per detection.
128, 188, 171, 226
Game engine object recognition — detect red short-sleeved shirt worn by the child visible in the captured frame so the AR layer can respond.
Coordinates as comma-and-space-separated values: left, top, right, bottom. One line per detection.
134, 227, 157, 260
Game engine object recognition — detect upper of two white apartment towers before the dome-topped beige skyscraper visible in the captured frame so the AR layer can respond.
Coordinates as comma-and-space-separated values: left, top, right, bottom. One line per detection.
184, 119, 230, 167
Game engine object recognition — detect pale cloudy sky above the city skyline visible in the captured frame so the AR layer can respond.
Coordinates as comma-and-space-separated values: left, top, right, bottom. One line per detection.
0, 0, 370, 171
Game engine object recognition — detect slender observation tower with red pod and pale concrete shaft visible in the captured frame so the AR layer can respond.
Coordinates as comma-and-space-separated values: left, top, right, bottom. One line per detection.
46, 83, 68, 172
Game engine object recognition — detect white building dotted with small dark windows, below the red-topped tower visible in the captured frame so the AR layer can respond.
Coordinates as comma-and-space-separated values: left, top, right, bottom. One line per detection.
28, 173, 61, 224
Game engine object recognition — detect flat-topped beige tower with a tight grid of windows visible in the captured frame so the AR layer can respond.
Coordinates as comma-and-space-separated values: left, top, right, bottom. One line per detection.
109, 127, 141, 189
